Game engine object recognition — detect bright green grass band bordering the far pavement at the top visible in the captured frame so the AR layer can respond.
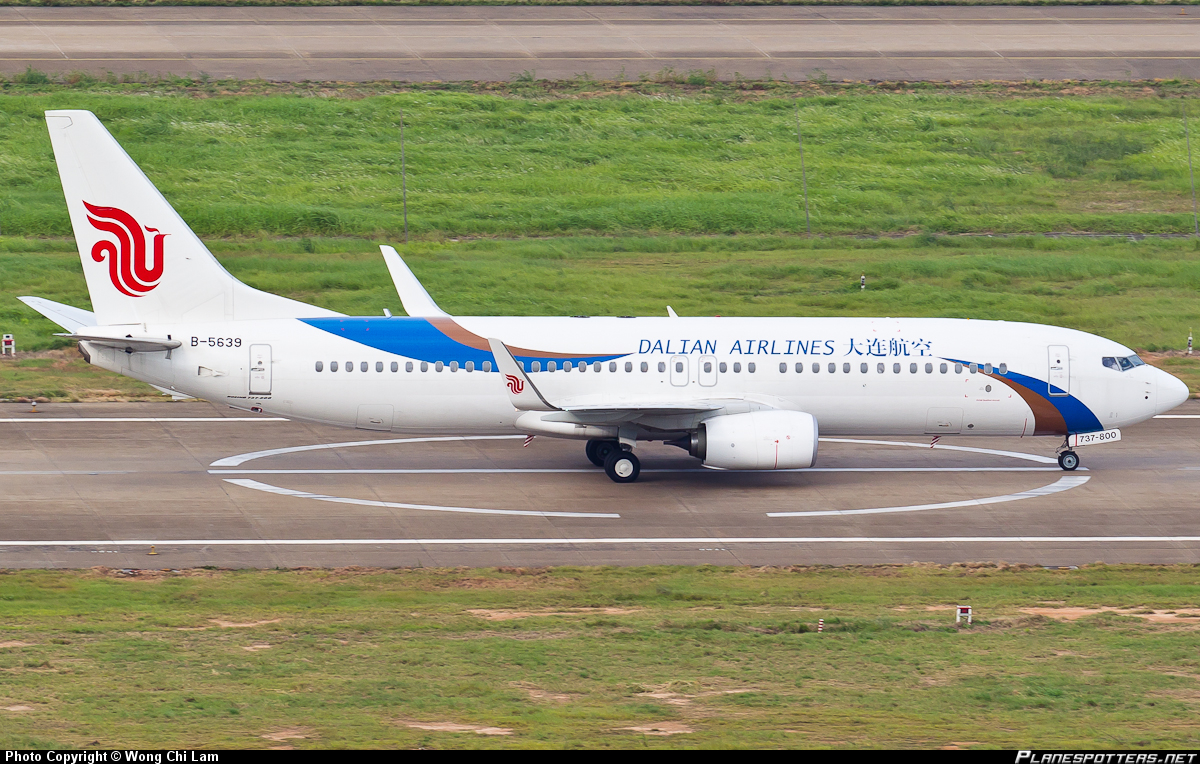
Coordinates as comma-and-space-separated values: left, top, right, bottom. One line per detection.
0, 85, 1192, 239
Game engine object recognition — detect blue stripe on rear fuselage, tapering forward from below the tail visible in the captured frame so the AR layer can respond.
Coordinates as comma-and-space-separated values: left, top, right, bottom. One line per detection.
300, 315, 622, 366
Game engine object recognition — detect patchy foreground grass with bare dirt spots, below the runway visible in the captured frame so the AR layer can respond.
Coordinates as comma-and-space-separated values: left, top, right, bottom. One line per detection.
0, 565, 1200, 750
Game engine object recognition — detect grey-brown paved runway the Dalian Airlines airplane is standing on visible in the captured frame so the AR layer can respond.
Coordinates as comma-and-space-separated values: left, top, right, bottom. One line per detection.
0, 401, 1200, 569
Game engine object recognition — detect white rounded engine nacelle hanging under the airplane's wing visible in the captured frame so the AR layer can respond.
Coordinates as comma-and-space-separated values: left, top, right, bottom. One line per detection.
694, 411, 817, 469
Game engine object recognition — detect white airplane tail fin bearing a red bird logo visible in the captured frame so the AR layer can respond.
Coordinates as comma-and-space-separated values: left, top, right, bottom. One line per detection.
44, 110, 340, 325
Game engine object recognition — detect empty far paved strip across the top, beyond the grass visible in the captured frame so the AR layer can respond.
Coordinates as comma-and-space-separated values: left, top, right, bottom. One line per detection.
0, 6, 1200, 82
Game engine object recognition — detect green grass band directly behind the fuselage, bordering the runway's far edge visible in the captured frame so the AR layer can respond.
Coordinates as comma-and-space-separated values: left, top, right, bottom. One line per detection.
0, 235, 1200, 399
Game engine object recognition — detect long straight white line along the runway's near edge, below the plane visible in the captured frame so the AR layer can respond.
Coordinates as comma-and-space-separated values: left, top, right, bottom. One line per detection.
7, 536, 1200, 548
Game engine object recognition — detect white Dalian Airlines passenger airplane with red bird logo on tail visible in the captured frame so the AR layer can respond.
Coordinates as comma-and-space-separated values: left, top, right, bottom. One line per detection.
22, 110, 1188, 482
